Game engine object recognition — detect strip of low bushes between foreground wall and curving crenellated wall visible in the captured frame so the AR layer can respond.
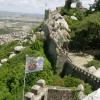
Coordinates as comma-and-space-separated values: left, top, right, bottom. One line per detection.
51, 76, 92, 95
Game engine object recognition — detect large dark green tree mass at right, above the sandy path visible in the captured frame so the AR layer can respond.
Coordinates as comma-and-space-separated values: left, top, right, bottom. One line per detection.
70, 12, 100, 50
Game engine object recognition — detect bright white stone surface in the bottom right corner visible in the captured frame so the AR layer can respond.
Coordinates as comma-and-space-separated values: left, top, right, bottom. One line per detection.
82, 88, 100, 100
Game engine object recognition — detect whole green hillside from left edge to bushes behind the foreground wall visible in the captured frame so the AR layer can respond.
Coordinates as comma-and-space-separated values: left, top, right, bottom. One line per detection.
0, 40, 91, 100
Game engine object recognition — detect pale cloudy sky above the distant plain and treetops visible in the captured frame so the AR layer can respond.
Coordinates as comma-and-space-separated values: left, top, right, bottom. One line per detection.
0, 0, 94, 14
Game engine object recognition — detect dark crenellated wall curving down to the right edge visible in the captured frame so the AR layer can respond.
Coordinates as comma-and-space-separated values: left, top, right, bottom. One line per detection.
63, 62, 100, 89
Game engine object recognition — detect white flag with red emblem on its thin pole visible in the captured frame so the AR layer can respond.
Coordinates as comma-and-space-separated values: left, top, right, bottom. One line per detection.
23, 55, 44, 100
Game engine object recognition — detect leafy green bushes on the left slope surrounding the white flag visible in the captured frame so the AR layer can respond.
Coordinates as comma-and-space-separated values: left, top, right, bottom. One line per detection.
0, 40, 53, 100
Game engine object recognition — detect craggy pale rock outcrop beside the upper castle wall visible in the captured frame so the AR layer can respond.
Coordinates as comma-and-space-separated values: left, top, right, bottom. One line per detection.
45, 12, 70, 52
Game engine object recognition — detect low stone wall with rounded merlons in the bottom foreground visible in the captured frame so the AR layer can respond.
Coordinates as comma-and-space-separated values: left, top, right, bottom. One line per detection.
25, 80, 73, 100
